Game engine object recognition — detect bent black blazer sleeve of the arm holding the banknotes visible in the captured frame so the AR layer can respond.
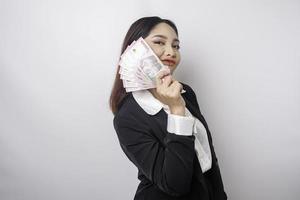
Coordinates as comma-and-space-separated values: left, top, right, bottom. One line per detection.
113, 113, 195, 196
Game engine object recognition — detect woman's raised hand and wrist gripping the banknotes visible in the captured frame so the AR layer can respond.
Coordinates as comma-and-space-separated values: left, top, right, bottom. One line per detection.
152, 70, 185, 116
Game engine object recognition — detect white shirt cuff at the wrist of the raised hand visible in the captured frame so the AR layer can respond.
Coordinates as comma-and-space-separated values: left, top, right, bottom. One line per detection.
167, 114, 195, 136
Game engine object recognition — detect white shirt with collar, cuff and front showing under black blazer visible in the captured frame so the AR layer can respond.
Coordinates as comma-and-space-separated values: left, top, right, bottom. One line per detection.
132, 90, 212, 173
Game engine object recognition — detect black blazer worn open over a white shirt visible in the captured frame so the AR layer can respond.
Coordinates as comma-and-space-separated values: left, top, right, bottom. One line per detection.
113, 83, 227, 200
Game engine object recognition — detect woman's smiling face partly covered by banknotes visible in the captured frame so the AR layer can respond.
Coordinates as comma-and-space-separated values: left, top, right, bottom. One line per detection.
145, 23, 180, 74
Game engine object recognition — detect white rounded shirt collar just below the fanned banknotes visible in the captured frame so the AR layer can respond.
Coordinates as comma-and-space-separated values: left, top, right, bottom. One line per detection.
132, 90, 185, 115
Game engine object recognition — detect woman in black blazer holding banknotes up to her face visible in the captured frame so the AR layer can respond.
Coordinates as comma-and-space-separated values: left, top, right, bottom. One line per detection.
110, 17, 227, 200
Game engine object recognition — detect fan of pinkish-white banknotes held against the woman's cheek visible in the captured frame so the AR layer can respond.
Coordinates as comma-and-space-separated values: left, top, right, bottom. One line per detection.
119, 37, 169, 92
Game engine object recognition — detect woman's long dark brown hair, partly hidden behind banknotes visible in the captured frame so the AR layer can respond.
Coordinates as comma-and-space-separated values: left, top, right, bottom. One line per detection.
109, 16, 178, 114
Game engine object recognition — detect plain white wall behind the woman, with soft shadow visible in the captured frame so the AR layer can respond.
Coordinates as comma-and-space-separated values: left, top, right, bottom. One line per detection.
0, 0, 300, 200
